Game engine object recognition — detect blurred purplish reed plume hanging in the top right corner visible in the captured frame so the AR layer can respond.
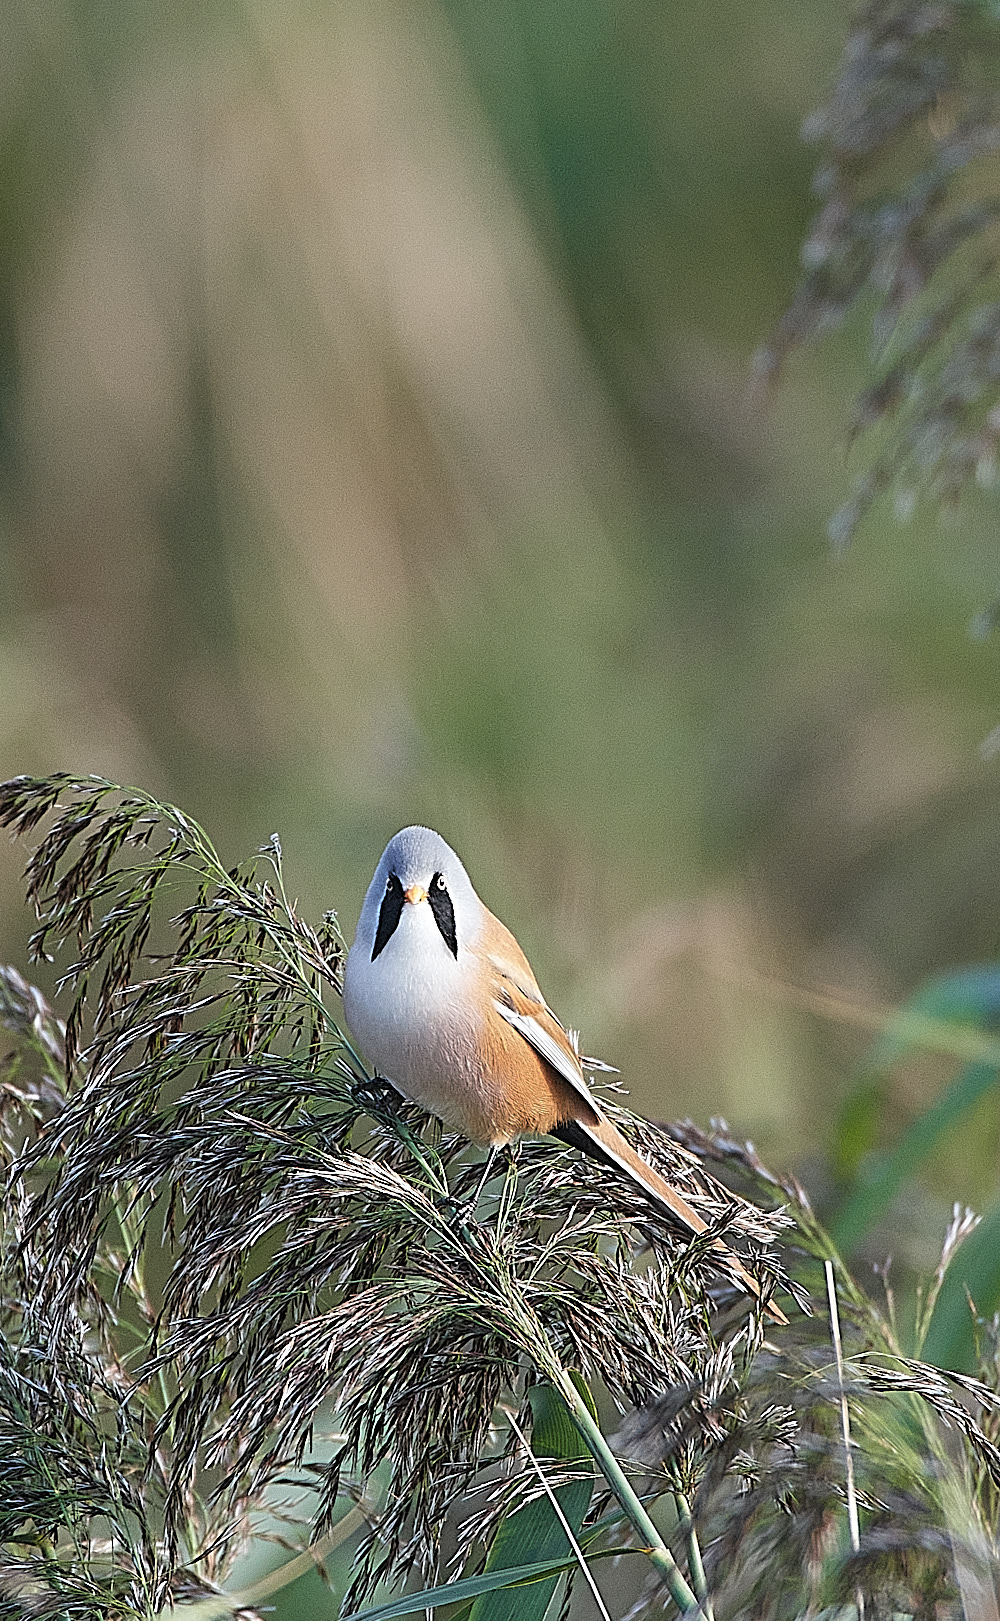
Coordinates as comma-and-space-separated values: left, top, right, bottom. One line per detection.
759, 0, 1000, 551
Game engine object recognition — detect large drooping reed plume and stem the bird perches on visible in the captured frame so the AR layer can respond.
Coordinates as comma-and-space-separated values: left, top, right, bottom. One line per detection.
0, 778, 786, 1605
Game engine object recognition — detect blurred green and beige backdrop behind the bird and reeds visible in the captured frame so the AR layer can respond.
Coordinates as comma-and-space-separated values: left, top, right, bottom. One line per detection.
0, 0, 1000, 1283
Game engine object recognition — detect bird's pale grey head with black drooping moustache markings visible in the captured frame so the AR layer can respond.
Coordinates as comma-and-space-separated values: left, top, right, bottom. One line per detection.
353, 827, 483, 961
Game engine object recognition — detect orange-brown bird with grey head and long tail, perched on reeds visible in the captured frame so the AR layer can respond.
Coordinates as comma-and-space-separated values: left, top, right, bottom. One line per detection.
344, 827, 788, 1323
